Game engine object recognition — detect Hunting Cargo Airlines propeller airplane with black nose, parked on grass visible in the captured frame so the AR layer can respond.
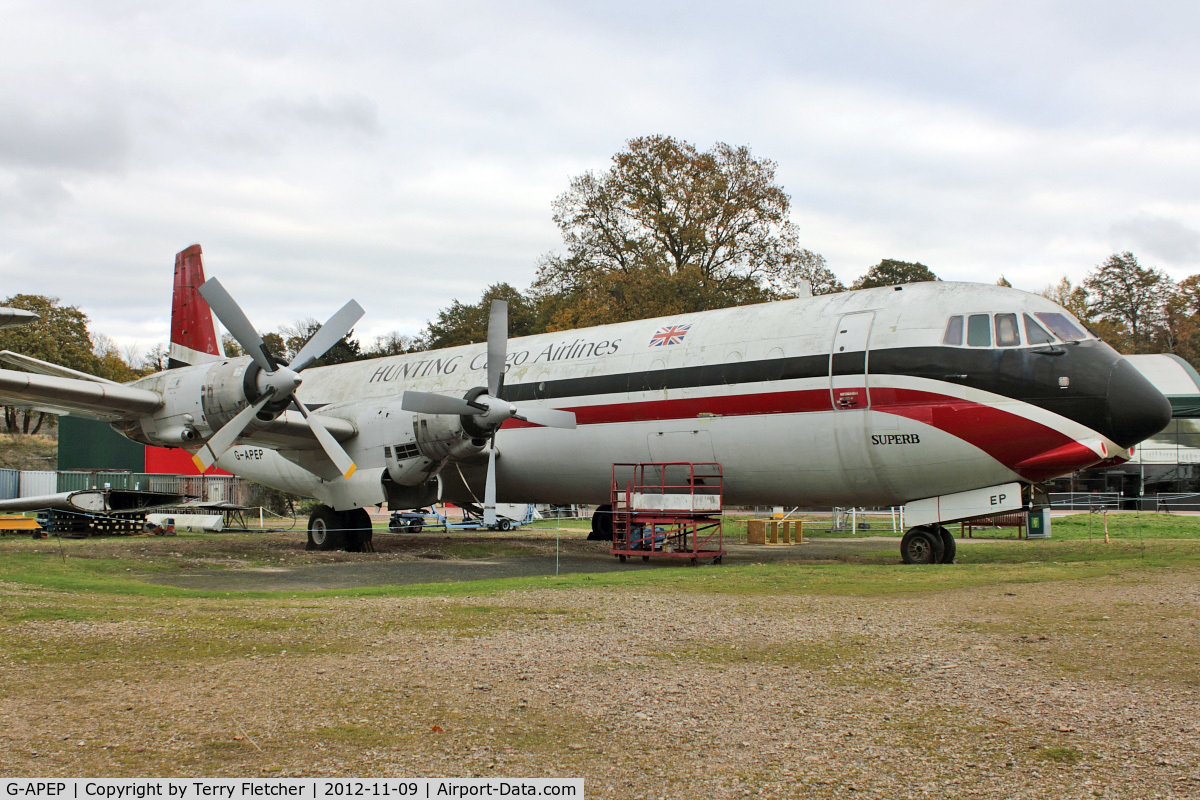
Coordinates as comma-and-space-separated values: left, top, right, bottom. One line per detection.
0, 247, 1171, 563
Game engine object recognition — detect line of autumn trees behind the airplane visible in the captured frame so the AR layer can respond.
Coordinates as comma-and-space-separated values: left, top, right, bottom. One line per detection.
0, 136, 1200, 433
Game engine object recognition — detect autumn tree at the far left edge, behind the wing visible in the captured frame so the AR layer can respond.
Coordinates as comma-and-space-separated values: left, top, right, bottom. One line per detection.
0, 294, 98, 433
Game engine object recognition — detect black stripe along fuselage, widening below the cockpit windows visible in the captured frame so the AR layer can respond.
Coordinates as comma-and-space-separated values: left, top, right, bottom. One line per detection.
489, 341, 1121, 438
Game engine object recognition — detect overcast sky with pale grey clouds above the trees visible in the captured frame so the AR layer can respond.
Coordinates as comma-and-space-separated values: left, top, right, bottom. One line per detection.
0, 0, 1200, 349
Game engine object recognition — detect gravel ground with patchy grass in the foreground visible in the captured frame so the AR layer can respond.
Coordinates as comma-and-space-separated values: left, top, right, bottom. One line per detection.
0, 541, 1200, 800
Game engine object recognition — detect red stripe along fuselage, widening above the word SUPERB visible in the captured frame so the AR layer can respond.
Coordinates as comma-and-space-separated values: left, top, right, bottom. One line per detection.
503, 386, 1099, 481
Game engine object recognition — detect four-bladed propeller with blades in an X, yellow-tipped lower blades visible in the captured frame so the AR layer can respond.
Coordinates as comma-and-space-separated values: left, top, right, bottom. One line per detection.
192, 278, 364, 477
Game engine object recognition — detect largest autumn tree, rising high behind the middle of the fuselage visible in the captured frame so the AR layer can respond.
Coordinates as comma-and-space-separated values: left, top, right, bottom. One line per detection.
533, 136, 800, 329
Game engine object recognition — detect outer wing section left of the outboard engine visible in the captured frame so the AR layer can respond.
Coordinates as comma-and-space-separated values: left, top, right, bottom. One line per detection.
0, 369, 162, 420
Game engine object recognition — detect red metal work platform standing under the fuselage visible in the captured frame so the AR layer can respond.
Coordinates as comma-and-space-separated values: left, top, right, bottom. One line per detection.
608, 462, 725, 564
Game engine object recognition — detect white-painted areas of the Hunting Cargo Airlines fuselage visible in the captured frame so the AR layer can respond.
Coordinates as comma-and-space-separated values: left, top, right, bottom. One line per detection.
208, 283, 1120, 506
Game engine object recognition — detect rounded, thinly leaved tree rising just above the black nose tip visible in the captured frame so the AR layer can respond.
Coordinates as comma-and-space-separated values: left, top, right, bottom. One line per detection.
1084, 251, 1174, 353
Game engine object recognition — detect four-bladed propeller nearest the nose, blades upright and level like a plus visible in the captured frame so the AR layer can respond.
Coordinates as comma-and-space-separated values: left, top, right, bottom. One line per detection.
400, 300, 575, 528
